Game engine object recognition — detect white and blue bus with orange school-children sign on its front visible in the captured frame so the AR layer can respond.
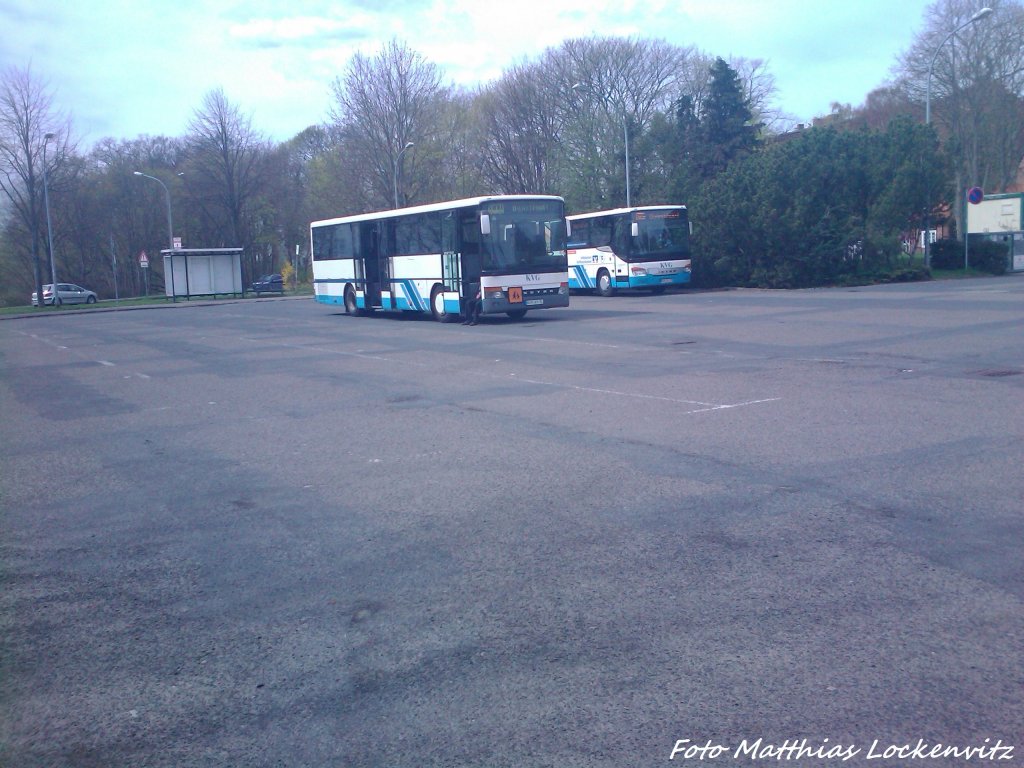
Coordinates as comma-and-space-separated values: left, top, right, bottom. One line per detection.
309, 195, 569, 323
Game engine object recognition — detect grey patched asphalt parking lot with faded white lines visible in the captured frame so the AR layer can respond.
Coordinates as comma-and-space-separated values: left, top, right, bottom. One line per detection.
0, 275, 1024, 768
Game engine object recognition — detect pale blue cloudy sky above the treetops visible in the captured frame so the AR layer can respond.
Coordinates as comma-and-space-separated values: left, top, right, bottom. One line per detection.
6, 0, 930, 145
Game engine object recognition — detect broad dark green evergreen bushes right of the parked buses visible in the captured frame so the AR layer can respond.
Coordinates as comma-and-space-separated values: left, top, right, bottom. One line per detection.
687, 120, 945, 288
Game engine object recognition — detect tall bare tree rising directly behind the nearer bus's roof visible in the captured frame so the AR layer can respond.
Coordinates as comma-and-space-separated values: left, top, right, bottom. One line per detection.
331, 40, 454, 209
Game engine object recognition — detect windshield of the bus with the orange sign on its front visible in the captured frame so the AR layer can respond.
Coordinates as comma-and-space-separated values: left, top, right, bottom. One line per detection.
480, 201, 567, 271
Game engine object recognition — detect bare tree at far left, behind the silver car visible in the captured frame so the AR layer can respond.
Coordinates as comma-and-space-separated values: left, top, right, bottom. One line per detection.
0, 66, 73, 309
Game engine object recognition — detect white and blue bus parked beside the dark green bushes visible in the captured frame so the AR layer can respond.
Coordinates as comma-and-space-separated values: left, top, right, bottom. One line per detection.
567, 205, 690, 296
